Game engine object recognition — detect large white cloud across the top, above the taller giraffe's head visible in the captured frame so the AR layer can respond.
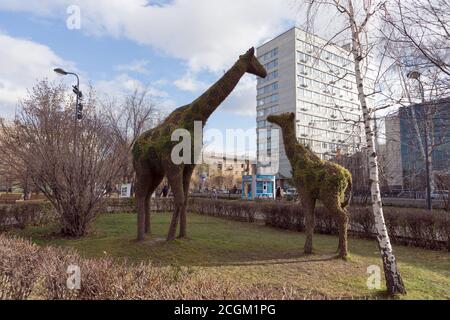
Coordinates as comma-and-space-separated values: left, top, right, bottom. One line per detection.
0, 0, 295, 72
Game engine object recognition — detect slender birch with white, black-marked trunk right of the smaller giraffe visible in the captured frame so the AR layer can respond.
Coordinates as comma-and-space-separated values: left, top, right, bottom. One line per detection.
298, 0, 406, 295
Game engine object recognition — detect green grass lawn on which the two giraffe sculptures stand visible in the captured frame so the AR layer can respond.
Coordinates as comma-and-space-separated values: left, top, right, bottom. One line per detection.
8, 214, 450, 299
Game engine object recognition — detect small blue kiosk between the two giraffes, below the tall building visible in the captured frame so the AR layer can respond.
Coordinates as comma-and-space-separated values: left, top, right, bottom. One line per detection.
242, 174, 276, 200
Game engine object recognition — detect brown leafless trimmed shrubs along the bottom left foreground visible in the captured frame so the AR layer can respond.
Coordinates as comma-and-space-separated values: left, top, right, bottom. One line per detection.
0, 235, 326, 300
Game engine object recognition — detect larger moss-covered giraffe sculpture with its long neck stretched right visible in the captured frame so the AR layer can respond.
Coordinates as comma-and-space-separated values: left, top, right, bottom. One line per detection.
133, 48, 267, 241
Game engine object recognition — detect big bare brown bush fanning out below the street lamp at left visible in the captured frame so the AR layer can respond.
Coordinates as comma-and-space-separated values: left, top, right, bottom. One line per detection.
0, 81, 123, 237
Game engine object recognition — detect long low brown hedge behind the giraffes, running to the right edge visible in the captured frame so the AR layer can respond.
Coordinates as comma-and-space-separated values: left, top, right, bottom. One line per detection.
146, 198, 450, 251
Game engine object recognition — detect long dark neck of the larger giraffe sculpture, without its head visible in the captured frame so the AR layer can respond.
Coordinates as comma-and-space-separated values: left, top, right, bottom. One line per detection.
192, 59, 247, 125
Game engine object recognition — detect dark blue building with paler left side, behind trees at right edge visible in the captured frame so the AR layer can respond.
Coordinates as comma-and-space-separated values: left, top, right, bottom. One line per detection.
386, 98, 450, 190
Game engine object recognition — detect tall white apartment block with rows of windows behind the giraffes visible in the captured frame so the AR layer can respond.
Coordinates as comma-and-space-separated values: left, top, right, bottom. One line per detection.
257, 28, 373, 178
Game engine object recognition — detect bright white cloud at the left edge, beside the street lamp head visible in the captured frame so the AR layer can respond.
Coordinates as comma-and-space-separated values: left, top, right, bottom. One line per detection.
0, 33, 75, 116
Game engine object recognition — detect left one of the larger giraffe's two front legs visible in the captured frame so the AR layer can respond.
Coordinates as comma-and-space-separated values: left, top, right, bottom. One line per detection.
166, 167, 185, 241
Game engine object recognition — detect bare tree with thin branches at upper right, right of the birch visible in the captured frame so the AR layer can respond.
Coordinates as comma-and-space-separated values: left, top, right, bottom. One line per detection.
380, 0, 450, 202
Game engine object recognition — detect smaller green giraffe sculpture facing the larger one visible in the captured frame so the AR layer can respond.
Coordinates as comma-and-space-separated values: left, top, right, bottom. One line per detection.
267, 113, 352, 258
